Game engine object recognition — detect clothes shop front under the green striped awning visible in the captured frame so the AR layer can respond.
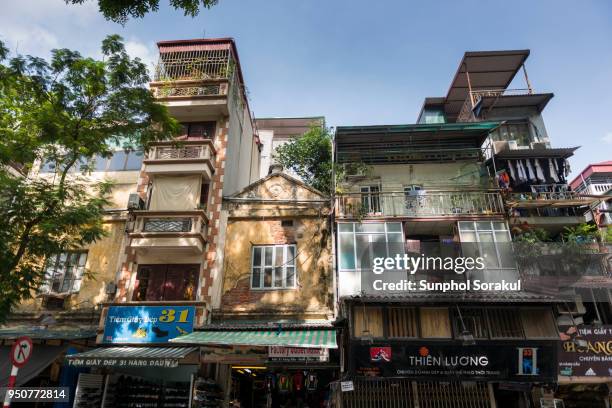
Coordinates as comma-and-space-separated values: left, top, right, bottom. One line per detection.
171, 327, 340, 408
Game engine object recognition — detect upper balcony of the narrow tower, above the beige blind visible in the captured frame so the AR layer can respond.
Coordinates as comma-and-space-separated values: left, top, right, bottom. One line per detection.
143, 139, 216, 180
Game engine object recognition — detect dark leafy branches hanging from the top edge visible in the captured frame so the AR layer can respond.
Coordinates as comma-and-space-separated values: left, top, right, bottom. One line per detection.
65, 0, 218, 24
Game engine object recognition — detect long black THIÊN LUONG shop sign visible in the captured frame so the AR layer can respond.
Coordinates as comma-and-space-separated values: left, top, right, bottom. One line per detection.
351, 341, 557, 382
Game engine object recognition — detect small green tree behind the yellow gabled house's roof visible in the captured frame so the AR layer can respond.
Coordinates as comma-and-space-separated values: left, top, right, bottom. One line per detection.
274, 126, 332, 194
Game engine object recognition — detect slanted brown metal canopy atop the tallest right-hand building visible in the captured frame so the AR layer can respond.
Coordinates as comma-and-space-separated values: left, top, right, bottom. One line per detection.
444, 50, 529, 120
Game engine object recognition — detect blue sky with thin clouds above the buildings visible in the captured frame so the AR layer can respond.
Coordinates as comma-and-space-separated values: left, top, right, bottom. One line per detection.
0, 0, 612, 178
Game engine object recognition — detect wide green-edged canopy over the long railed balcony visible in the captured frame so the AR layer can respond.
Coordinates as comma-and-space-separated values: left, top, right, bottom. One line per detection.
334, 122, 501, 164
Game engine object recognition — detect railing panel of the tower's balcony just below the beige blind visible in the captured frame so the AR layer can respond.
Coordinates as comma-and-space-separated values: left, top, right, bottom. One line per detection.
129, 210, 208, 241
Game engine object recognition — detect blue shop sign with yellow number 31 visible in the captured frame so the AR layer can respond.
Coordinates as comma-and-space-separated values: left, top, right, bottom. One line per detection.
102, 306, 195, 344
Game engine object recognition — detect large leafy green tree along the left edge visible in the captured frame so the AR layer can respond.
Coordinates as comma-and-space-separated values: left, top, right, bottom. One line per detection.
0, 35, 179, 321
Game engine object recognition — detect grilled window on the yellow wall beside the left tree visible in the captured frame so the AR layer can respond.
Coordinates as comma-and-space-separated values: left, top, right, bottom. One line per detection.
41, 251, 87, 293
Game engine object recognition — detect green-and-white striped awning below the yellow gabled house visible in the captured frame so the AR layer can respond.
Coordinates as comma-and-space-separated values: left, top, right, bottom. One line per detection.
170, 330, 338, 349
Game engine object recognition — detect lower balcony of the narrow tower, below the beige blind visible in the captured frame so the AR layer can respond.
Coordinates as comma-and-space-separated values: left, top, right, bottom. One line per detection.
128, 210, 208, 253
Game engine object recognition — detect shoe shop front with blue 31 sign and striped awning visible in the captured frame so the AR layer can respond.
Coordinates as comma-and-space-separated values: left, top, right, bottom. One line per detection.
65, 305, 207, 408
